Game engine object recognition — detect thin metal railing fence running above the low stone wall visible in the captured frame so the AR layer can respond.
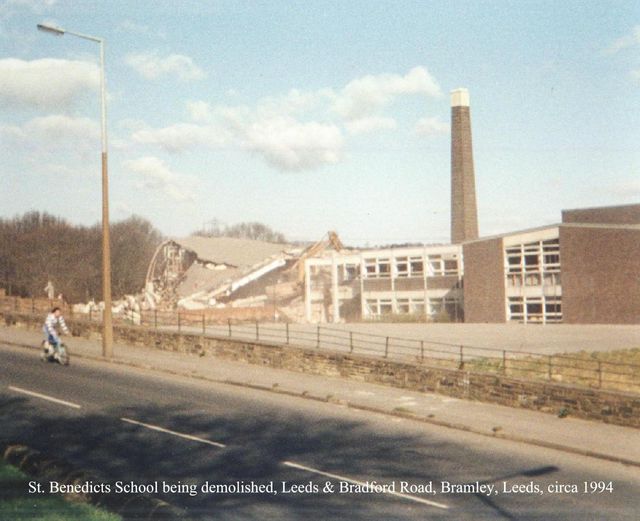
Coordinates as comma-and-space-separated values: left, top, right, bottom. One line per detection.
0, 297, 640, 393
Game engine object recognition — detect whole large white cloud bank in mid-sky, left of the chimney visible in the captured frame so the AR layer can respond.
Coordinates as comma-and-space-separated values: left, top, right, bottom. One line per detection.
132, 67, 440, 171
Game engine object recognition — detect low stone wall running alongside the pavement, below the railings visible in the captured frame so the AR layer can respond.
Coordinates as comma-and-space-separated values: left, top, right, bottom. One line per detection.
3, 313, 640, 428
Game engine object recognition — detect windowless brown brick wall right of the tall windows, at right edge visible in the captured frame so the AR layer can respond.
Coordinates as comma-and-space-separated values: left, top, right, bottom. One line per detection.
560, 226, 640, 324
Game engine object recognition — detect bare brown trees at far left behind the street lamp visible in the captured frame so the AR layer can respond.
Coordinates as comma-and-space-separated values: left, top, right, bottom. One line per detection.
0, 212, 162, 302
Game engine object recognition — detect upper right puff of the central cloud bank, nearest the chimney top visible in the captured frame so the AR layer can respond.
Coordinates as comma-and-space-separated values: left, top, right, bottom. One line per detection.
333, 67, 441, 120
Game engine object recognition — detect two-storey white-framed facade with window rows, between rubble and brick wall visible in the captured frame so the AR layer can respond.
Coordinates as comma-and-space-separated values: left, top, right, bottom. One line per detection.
305, 245, 464, 322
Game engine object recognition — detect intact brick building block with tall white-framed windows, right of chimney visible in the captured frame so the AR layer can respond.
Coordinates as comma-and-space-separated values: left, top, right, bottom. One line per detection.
463, 205, 640, 324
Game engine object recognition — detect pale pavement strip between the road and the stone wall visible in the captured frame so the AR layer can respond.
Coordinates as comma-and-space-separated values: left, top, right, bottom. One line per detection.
0, 326, 640, 467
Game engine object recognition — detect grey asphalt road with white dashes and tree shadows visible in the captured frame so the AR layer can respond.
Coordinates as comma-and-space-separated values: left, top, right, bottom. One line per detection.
0, 346, 640, 521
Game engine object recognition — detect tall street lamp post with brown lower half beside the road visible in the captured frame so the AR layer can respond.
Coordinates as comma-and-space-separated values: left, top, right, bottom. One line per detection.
38, 24, 113, 358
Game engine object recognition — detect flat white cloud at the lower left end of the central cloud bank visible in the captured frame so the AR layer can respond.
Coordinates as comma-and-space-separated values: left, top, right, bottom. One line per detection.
131, 123, 228, 153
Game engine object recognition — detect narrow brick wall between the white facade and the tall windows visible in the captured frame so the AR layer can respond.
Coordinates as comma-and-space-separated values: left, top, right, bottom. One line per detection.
463, 238, 506, 322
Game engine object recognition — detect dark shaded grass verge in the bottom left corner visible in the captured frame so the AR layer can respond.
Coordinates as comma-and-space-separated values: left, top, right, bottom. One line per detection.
0, 461, 122, 521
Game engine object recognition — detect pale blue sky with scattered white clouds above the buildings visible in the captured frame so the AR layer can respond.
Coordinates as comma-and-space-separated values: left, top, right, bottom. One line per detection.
0, 0, 640, 246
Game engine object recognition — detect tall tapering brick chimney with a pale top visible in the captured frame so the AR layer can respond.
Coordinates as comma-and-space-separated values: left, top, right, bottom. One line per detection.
451, 89, 478, 244
